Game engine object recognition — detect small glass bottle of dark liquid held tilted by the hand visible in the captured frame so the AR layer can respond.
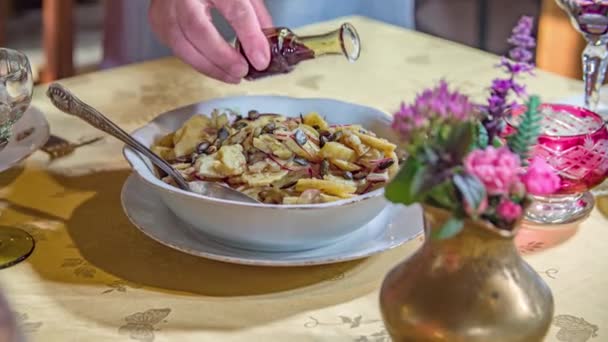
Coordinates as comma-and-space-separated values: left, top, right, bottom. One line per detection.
236, 23, 361, 80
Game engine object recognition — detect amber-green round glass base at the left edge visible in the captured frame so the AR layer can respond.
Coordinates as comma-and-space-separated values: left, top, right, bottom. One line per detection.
0, 227, 35, 269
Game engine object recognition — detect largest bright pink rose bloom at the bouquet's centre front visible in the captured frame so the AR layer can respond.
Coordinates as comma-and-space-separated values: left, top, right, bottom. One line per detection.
464, 146, 521, 195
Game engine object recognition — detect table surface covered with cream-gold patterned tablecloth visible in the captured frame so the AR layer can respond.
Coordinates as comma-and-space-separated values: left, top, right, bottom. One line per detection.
0, 17, 608, 342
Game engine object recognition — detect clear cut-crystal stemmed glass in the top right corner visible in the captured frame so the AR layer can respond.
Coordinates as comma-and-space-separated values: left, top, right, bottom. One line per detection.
556, 0, 608, 115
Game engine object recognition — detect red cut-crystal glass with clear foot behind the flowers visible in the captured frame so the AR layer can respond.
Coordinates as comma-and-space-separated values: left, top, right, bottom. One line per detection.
506, 104, 608, 225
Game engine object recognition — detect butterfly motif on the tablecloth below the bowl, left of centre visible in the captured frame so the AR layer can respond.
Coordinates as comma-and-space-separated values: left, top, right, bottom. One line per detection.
118, 308, 171, 342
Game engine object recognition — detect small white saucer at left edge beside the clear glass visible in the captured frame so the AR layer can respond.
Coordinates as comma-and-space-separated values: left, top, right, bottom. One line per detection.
0, 107, 50, 172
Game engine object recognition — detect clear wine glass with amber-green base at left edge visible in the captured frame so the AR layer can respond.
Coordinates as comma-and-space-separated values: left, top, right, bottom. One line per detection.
0, 48, 34, 268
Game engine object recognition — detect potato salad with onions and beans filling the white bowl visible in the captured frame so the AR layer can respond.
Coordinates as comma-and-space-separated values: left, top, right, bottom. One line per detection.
152, 110, 399, 205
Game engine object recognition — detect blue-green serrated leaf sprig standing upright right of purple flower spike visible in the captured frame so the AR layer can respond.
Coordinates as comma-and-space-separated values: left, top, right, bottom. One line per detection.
507, 95, 541, 163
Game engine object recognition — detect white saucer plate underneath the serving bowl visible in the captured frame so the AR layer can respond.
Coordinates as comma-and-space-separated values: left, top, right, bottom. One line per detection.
121, 175, 423, 267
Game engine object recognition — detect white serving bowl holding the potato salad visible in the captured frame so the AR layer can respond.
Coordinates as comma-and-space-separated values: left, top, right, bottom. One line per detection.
124, 96, 400, 252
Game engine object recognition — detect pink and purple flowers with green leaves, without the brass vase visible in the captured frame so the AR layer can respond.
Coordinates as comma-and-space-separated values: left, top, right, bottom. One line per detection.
386, 17, 559, 238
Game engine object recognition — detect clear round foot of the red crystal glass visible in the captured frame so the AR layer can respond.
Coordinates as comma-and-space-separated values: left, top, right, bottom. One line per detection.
525, 192, 595, 225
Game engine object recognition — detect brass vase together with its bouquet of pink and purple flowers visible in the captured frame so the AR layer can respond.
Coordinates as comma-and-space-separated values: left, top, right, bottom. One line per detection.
380, 17, 559, 342
